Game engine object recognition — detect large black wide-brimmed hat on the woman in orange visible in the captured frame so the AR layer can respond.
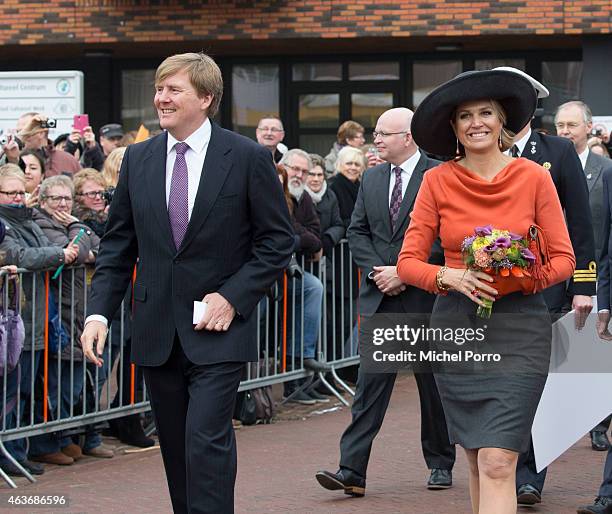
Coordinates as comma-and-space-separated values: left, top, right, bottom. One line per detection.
411, 70, 538, 155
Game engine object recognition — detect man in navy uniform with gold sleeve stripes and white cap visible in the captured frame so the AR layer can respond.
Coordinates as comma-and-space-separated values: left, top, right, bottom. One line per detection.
496, 67, 596, 505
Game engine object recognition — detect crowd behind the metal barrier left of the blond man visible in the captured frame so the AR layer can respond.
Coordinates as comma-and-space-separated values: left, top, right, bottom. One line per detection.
0, 112, 154, 476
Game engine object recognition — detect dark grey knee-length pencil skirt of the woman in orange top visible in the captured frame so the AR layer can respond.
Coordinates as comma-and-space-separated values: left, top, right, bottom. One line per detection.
430, 292, 552, 452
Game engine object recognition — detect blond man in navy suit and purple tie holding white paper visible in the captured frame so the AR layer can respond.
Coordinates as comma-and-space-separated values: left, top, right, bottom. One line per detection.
81, 53, 294, 514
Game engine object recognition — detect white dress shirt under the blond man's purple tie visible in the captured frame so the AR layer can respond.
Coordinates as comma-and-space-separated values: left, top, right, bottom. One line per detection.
85, 118, 212, 326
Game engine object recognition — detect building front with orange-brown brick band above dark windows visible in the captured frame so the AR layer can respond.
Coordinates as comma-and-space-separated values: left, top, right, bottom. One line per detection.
0, 0, 612, 153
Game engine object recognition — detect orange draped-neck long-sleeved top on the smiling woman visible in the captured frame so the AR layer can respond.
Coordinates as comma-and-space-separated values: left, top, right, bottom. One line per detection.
397, 158, 576, 292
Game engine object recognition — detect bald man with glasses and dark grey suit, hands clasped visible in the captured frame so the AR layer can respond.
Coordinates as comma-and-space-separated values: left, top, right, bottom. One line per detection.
316, 108, 455, 496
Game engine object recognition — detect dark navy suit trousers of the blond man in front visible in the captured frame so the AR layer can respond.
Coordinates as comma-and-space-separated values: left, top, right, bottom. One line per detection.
142, 337, 244, 514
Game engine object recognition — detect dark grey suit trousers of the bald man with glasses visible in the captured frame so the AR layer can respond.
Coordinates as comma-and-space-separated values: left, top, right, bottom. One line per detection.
340, 297, 455, 478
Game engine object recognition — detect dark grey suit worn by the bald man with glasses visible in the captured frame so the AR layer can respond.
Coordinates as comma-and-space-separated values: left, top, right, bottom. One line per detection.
340, 154, 455, 478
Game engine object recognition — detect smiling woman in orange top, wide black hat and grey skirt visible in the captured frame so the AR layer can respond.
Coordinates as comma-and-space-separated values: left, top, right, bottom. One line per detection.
397, 70, 575, 514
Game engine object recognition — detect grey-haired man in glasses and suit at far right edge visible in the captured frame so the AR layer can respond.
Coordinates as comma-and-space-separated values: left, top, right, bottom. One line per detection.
555, 100, 612, 451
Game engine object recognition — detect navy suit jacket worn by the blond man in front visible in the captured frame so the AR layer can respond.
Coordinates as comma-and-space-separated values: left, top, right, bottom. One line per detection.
88, 123, 294, 366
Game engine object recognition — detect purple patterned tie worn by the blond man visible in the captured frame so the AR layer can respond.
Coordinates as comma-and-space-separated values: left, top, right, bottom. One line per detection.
168, 143, 189, 250
